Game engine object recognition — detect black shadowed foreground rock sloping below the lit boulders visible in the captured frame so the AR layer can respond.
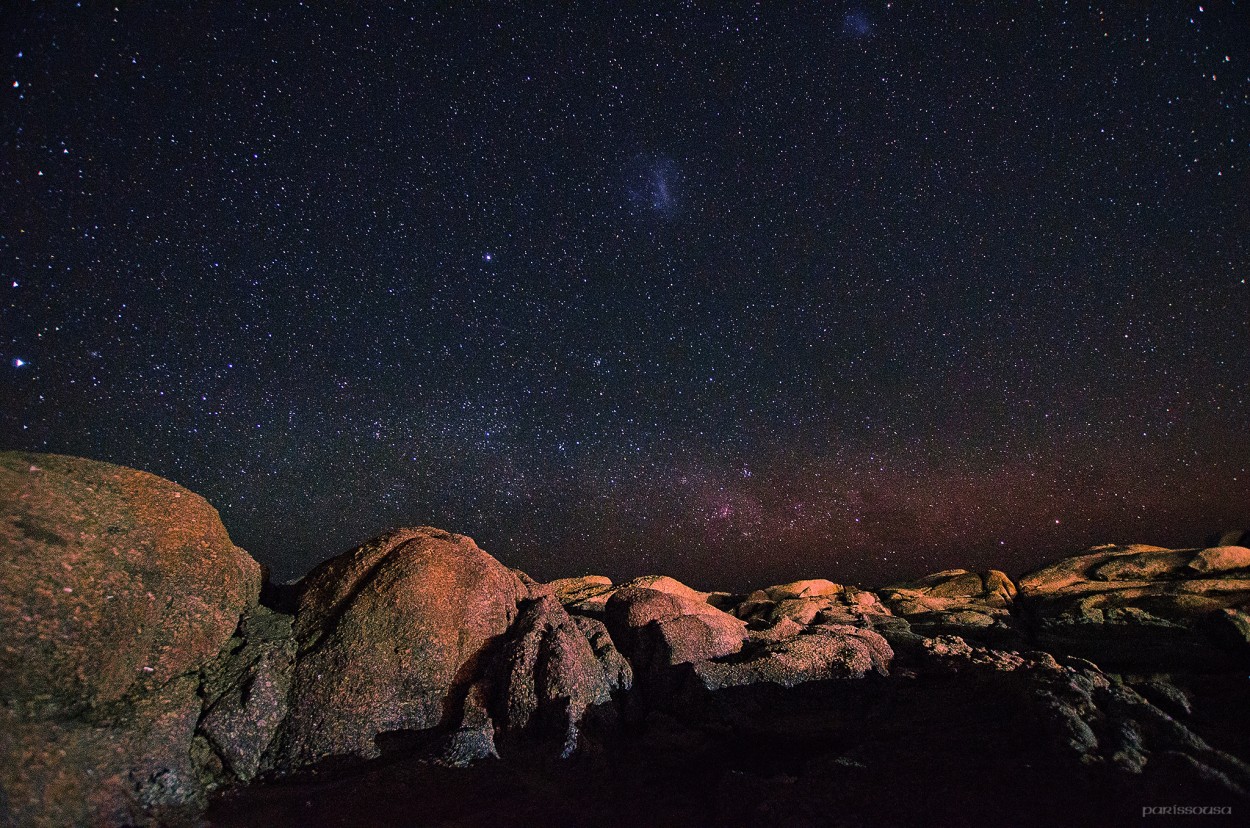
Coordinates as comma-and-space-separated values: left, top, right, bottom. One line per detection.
210, 640, 1246, 828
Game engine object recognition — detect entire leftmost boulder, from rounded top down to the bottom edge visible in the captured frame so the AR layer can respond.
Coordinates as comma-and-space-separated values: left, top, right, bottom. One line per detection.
0, 453, 261, 825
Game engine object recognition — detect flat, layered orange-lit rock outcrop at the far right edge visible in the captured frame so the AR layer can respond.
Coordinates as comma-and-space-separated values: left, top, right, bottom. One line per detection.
1019, 545, 1250, 670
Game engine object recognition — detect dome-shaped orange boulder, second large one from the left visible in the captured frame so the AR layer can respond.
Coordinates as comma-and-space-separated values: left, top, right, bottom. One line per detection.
280, 527, 530, 768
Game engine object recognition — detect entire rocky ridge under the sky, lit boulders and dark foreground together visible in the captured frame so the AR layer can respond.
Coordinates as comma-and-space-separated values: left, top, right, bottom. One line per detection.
0, 453, 1250, 825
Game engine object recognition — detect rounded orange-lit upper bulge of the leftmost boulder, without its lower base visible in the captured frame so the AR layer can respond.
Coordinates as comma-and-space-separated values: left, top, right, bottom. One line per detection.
0, 453, 260, 714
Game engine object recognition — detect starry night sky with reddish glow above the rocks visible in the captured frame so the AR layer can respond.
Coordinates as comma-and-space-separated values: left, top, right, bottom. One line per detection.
0, 1, 1250, 589
